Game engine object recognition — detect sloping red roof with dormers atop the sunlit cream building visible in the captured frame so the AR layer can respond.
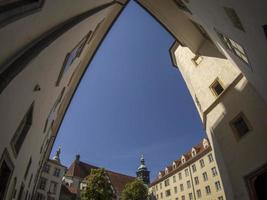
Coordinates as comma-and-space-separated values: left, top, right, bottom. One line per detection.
149, 138, 211, 187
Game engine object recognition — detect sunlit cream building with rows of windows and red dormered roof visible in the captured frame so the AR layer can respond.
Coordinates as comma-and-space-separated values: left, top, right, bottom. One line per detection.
149, 139, 226, 200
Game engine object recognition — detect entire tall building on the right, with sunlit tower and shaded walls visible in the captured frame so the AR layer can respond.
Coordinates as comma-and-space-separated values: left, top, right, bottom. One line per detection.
138, 0, 267, 200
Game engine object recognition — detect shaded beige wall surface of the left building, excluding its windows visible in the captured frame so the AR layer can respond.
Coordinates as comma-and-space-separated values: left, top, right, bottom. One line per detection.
0, 0, 126, 198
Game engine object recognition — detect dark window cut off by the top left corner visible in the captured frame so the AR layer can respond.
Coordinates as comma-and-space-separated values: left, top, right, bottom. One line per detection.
0, 0, 43, 27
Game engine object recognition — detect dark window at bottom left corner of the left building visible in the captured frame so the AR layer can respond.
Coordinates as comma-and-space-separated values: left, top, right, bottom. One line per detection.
0, 149, 14, 200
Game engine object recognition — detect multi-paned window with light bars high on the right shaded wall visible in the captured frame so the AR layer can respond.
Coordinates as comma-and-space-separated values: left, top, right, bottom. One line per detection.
215, 30, 249, 64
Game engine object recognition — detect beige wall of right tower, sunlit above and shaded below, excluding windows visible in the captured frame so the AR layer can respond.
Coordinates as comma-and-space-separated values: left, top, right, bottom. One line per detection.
174, 41, 267, 199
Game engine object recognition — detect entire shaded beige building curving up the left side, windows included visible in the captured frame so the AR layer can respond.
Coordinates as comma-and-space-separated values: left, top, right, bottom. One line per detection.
0, 0, 129, 200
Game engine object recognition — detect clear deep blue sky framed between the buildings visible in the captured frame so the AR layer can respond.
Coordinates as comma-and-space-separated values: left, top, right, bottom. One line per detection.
52, 1, 205, 180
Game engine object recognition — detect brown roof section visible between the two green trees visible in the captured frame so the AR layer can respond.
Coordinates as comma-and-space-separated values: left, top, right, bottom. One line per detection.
106, 170, 135, 194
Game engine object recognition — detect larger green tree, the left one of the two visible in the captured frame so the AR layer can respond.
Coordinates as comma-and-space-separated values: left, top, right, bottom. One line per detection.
81, 169, 115, 200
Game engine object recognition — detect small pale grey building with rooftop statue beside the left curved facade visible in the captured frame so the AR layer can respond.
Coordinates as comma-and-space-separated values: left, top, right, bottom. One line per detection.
34, 149, 67, 200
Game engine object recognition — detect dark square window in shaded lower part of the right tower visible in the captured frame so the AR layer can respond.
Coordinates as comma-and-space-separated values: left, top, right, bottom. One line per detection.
230, 113, 251, 139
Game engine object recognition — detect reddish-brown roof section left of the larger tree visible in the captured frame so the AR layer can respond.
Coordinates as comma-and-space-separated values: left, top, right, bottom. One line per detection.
65, 160, 98, 179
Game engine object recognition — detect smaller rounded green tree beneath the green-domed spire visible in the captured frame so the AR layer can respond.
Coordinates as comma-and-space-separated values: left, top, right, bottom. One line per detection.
121, 179, 148, 200
